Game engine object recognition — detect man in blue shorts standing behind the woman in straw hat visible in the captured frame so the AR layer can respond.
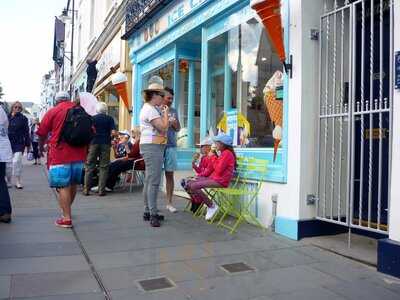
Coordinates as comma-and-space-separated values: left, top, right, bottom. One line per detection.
164, 87, 181, 213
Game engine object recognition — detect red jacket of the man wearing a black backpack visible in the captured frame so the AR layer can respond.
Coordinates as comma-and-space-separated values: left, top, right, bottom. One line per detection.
36, 101, 87, 167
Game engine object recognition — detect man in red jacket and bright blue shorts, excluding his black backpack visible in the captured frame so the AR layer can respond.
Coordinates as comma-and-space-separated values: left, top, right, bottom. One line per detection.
37, 92, 87, 228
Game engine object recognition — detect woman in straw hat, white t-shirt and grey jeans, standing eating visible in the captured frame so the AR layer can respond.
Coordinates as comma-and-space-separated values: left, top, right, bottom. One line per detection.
139, 76, 169, 227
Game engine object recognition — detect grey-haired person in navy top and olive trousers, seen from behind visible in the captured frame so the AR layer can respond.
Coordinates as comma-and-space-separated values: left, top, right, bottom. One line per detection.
83, 102, 116, 196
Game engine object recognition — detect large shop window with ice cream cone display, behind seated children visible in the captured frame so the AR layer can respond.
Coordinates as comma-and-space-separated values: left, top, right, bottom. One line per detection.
207, 18, 283, 148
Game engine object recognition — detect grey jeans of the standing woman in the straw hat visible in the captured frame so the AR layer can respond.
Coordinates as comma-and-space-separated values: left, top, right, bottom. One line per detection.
140, 144, 165, 216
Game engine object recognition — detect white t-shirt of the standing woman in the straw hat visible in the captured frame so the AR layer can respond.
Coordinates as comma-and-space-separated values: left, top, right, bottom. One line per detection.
139, 103, 165, 144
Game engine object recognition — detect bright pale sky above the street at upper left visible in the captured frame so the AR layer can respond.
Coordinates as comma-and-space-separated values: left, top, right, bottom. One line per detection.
0, 0, 67, 102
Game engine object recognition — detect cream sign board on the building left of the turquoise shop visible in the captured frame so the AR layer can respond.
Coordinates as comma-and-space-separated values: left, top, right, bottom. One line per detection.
97, 35, 121, 80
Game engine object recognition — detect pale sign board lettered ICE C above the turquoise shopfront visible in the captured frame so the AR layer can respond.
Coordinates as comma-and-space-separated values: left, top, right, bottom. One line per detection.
134, 0, 207, 48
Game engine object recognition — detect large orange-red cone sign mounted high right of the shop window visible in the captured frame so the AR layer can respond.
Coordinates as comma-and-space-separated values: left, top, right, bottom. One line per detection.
250, 0, 286, 64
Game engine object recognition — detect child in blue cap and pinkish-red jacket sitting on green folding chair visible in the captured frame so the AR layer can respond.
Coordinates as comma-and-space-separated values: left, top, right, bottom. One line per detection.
184, 133, 236, 220
